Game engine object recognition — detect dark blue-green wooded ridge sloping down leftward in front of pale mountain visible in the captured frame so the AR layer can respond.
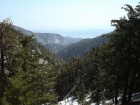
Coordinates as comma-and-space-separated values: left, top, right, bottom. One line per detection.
58, 34, 109, 61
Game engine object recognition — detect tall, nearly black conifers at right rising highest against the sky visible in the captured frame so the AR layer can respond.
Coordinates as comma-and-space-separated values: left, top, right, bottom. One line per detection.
101, 2, 139, 105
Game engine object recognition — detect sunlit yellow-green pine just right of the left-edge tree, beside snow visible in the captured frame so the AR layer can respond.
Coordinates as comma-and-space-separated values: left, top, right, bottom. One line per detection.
18, 36, 57, 105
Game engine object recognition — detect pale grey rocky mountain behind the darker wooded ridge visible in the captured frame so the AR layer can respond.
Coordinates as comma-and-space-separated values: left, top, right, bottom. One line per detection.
14, 26, 82, 53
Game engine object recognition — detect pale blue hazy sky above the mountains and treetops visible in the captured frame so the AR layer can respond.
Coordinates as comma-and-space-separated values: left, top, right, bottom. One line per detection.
0, 0, 139, 37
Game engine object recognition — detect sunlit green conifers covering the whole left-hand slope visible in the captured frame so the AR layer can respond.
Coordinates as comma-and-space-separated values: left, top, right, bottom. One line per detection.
0, 20, 58, 105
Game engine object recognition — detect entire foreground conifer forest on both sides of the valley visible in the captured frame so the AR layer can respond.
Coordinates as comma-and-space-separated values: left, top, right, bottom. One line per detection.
0, 2, 140, 105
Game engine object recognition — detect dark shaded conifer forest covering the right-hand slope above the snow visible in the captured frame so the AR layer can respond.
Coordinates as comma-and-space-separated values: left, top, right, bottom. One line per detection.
56, 2, 140, 105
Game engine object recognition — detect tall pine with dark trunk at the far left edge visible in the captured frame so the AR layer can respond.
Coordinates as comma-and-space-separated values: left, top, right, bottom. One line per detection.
0, 19, 20, 105
